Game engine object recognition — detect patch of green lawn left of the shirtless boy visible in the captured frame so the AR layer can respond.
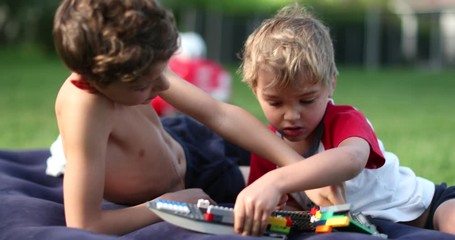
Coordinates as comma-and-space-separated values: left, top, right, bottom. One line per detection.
0, 48, 68, 149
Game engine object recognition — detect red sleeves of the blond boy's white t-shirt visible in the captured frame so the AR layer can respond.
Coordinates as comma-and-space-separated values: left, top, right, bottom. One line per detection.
248, 101, 385, 185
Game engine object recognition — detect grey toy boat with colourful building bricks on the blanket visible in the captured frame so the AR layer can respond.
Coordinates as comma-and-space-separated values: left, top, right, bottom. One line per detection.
147, 199, 386, 239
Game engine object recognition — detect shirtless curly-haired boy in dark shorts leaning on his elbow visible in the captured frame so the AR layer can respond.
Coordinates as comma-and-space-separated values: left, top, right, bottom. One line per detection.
53, 0, 301, 235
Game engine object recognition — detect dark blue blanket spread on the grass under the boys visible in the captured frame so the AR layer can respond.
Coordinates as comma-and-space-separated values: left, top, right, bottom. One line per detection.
0, 150, 455, 240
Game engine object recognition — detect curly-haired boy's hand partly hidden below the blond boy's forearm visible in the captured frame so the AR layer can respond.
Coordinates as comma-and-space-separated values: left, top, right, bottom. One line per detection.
305, 183, 346, 207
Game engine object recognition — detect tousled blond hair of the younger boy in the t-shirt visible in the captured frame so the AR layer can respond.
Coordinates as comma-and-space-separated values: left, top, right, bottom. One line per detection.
240, 3, 338, 89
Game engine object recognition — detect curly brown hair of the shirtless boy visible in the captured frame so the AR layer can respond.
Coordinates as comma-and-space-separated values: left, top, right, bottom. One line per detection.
53, 0, 178, 85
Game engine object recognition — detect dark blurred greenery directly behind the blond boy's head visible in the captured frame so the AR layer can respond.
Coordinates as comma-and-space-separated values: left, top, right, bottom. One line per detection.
162, 0, 393, 68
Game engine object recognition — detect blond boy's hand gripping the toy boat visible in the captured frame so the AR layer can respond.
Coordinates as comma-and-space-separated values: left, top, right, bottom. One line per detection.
234, 183, 287, 236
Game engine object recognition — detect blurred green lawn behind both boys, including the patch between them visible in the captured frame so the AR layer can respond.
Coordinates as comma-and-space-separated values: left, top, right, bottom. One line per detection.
0, 48, 455, 185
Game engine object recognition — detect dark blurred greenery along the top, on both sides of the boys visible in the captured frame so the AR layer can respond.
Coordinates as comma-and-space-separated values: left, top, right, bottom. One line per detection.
0, 0, 444, 68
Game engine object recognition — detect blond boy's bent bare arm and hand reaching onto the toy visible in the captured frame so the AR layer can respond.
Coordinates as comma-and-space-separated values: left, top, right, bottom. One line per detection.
234, 137, 370, 235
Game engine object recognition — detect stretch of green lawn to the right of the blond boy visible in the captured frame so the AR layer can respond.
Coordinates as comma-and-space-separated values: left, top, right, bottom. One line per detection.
335, 69, 455, 184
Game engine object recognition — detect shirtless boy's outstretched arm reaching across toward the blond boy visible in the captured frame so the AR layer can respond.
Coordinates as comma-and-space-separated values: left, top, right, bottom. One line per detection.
160, 69, 303, 166
